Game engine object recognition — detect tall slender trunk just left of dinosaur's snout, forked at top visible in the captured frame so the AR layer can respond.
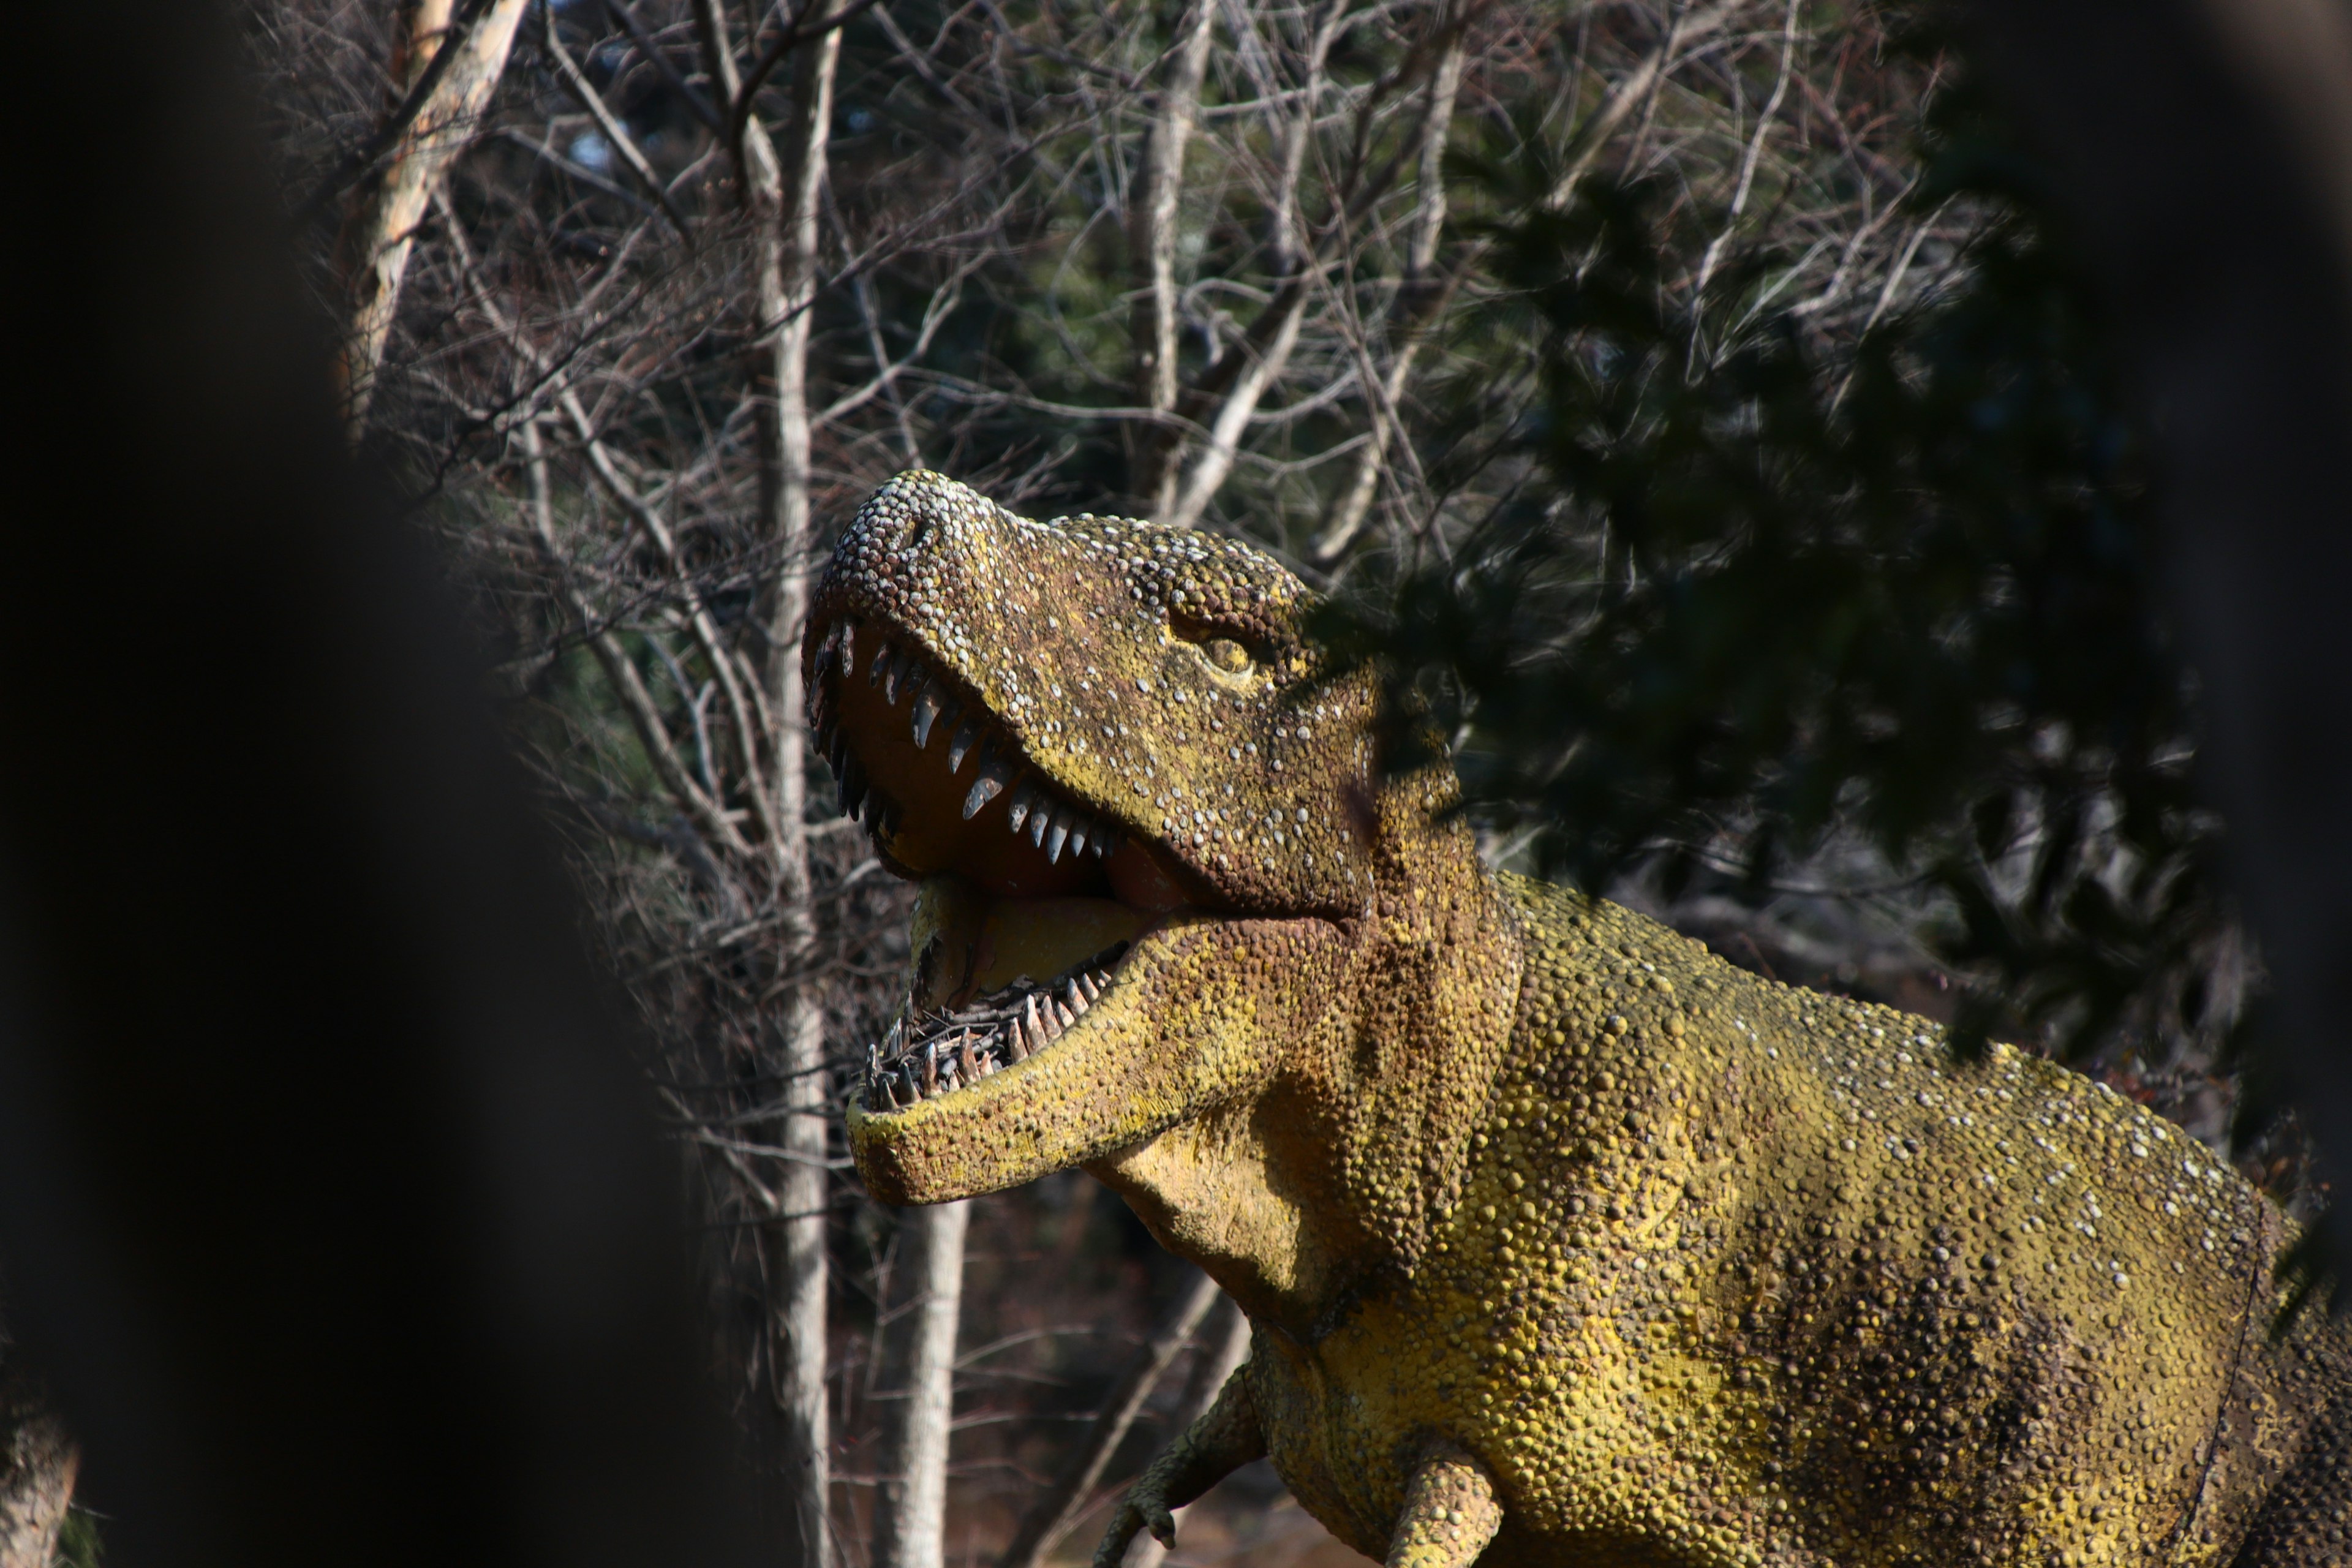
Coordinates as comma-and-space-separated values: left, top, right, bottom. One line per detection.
696, 0, 842, 1568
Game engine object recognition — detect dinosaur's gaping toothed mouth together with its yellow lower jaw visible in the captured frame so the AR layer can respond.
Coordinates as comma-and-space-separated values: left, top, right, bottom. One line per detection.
809, 611, 1333, 1204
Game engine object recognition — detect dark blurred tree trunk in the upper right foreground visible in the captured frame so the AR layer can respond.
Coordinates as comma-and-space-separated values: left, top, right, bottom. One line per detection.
1969, 0, 2352, 1260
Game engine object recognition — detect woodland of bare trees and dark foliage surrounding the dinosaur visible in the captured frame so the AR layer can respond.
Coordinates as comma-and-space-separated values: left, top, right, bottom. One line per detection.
50, 0, 2315, 1563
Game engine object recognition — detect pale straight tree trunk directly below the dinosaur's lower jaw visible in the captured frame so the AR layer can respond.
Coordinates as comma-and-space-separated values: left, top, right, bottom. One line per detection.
875, 1201, 971, 1568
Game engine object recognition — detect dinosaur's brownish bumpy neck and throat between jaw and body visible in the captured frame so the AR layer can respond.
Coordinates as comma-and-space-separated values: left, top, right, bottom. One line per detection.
1091, 830, 1521, 1340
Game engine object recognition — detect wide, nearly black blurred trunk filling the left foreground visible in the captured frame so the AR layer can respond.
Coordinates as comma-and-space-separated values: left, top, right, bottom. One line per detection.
0, 5, 748, 1566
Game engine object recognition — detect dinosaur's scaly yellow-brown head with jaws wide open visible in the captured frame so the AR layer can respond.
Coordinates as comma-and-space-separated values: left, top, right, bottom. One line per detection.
802, 470, 1376, 1204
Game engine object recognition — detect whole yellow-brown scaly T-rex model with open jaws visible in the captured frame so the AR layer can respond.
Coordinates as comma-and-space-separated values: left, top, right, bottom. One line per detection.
802, 472, 2352, 1568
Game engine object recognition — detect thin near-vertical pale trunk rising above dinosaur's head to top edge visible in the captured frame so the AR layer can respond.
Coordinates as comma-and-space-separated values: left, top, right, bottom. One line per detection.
1126, 0, 1216, 517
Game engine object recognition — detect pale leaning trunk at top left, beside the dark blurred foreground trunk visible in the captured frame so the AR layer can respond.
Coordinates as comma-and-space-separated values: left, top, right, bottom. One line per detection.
336, 0, 527, 442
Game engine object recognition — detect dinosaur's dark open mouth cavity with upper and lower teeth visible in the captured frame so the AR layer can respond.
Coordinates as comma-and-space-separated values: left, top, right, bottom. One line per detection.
809, 616, 1213, 1114
